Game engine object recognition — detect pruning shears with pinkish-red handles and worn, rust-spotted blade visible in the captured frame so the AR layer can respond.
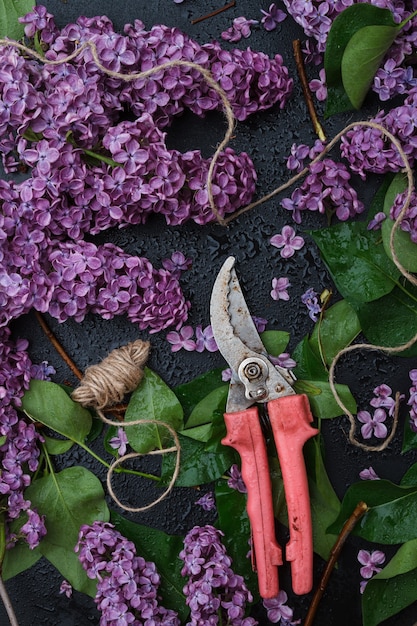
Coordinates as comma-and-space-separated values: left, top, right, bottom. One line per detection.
210, 257, 319, 598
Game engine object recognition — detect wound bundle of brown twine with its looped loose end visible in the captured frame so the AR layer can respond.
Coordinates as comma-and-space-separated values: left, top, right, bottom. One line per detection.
71, 339, 181, 513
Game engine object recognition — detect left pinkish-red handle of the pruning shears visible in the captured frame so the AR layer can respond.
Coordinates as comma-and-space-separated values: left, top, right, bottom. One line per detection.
222, 407, 282, 598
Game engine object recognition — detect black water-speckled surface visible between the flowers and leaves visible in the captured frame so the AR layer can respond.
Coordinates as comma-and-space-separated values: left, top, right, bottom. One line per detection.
0, 0, 417, 626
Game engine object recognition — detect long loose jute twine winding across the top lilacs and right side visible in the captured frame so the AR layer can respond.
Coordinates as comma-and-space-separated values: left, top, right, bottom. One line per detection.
0, 39, 417, 448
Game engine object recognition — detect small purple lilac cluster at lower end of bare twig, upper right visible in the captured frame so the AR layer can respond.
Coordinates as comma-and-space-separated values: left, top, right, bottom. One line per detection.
281, 141, 365, 224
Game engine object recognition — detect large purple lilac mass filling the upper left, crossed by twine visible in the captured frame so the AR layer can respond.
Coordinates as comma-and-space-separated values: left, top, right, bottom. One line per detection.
0, 6, 292, 332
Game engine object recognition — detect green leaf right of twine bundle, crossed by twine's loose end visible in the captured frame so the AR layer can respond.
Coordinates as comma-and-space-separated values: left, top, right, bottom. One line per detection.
125, 367, 183, 454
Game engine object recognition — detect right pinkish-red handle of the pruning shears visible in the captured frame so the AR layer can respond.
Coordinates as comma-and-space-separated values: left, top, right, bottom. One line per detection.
268, 394, 319, 595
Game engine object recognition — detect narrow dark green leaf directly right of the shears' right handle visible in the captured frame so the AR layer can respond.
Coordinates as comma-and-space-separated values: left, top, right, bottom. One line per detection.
304, 436, 340, 561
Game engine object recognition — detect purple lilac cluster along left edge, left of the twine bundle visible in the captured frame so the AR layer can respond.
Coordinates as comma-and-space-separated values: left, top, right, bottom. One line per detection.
0, 328, 46, 549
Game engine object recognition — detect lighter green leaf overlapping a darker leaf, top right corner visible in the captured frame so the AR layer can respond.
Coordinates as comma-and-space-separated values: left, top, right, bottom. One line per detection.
341, 21, 401, 109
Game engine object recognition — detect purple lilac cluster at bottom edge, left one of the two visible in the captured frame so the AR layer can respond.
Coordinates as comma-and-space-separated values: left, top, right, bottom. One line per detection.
75, 522, 180, 626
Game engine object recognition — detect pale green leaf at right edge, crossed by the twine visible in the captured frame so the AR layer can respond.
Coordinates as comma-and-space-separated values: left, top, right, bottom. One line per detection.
381, 173, 417, 272
